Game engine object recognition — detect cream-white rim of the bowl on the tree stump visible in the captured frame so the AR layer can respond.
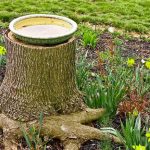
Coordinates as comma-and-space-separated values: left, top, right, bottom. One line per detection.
9, 14, 77, 39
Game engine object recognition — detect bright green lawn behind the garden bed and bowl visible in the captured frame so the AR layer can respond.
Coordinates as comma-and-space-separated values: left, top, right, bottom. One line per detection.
0, 0, 150, 33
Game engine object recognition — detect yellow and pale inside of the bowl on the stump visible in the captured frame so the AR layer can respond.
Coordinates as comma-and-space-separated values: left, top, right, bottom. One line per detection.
14, 16, 73, 39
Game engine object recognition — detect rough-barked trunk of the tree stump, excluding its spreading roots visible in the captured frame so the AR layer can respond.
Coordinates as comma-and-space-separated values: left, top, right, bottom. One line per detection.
0, 32, 85, 121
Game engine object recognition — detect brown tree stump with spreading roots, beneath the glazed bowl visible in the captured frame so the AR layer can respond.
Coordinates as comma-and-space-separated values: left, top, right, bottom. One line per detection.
0, 32, 121, 150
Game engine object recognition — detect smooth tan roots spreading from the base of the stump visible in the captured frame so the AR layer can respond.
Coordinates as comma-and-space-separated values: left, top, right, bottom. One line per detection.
0, 108, 122, 150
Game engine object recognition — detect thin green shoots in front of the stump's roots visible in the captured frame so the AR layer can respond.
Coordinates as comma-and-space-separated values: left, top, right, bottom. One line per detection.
21, 113, 46, 150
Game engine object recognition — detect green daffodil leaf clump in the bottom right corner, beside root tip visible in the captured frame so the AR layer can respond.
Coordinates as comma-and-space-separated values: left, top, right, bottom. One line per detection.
101, 114, 150, 150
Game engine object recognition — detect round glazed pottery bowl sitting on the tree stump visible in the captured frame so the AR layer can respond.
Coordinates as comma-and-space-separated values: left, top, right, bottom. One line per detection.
9, 14, 77, 45
